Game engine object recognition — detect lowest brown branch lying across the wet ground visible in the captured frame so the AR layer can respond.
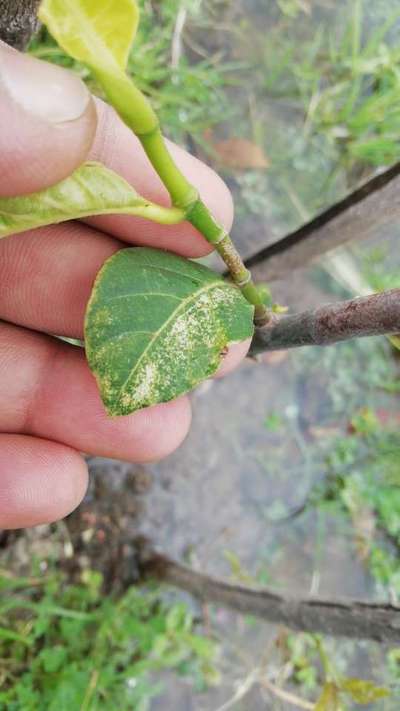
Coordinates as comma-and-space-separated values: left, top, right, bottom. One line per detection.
143, 552, 400, 644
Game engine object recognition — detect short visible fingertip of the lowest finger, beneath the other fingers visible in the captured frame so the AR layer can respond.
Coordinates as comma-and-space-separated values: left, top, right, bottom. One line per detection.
0, 434, 88, 529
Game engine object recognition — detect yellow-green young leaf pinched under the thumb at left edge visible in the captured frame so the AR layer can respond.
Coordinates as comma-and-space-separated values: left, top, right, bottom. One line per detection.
0, 163, 182, 238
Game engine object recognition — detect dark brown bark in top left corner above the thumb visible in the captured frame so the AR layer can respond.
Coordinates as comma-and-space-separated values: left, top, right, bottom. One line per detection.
0, 0, 40, 50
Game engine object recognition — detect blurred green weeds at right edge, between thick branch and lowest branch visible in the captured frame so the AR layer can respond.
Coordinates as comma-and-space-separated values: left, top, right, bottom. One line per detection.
304, 409, 400, 597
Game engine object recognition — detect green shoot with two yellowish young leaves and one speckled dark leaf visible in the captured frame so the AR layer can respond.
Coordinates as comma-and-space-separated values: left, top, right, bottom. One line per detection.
0, 0, 269, 415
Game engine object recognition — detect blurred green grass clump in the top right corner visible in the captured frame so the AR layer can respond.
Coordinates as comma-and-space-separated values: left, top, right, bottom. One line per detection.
262, 0, 400, 171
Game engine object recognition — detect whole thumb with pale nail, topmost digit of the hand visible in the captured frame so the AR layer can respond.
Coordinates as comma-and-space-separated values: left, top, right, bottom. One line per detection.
0, 41, 97, 196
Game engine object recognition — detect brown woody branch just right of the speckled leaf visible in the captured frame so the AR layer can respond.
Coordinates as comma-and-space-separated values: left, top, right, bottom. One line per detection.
250, 289, 400, 355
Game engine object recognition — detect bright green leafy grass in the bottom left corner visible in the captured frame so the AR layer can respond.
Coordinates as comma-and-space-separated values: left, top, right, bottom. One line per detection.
0, 570, 218, 711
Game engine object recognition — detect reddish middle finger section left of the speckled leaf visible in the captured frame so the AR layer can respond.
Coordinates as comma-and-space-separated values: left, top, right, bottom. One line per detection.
0, 222, 122, 338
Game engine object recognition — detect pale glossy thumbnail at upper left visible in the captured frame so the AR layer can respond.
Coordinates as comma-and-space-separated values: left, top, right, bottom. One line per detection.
0, 42, 90, 124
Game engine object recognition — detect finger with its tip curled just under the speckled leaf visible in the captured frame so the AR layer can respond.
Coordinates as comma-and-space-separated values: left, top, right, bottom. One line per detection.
0, 324, 191, 462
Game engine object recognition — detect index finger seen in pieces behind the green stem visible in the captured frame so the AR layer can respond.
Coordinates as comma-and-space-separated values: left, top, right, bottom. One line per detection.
88, 100, 233, 257
